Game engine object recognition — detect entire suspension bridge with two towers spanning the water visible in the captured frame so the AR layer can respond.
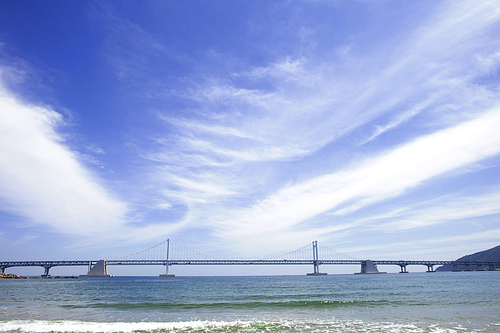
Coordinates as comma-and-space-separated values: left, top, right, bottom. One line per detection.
0, 239, 500, 277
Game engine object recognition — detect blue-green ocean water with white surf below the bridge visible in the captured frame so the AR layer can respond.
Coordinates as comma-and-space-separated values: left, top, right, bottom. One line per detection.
0, 272, 500, 332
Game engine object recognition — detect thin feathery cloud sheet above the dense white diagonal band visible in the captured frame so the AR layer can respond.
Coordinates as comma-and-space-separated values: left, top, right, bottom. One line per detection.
153, 3, 500, 174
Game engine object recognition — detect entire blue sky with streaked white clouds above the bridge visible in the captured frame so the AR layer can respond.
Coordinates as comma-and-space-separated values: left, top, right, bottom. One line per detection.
0, 0, 500, 275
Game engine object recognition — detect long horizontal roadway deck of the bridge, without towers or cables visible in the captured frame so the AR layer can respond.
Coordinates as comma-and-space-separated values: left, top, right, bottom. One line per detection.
0, 259, 500, 276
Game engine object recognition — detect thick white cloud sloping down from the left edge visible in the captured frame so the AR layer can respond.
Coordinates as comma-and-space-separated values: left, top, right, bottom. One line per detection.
0, 78, 127, 236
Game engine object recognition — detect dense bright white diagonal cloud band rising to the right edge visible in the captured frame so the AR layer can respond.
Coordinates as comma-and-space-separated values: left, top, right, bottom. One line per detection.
218, 108, 500, 253
